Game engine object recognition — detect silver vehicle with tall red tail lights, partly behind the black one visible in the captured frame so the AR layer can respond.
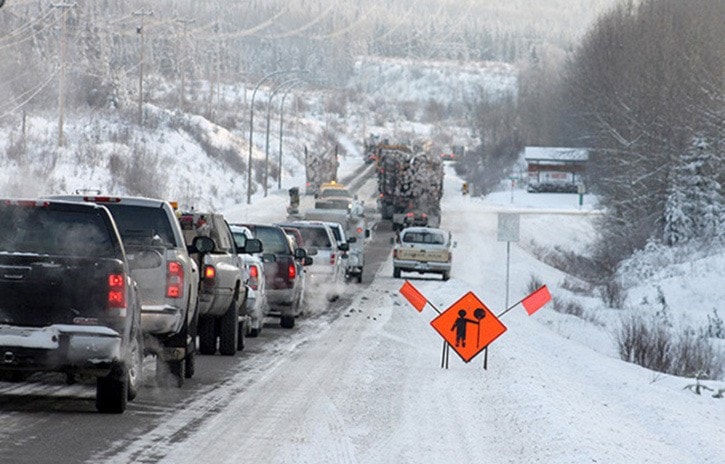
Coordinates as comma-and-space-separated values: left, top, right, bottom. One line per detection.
51, 195, 199, 386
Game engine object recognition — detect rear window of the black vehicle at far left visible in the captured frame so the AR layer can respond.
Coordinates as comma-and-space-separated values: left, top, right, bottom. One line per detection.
0, 206, 115, 257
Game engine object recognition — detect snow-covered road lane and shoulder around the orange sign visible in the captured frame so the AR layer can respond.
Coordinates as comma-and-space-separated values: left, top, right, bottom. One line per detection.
104, 170, 725, 464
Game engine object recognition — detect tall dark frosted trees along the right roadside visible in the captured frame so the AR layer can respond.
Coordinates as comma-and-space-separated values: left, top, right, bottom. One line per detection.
462, 0, 725, 272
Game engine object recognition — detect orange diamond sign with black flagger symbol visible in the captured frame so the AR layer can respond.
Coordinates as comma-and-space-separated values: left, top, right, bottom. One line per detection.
430, 292, 506, 362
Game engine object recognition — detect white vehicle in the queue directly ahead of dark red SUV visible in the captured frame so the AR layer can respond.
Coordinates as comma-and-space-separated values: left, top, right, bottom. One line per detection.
278, 221, 349, 301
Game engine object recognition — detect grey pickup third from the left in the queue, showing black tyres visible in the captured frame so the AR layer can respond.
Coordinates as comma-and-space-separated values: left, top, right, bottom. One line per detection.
179, 212, 247, 356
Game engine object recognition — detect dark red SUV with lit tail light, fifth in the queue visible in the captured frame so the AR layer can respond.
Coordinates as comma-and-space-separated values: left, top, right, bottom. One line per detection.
235, 224, 307, 329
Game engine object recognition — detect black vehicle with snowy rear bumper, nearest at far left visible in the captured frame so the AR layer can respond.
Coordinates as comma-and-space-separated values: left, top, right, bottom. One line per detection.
0, 200, 143, 413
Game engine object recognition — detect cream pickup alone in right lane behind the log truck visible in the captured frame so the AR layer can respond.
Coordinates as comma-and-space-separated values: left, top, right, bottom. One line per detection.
393, 227, 456, 280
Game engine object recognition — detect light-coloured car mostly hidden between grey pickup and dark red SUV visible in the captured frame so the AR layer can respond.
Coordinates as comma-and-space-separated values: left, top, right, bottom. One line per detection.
230, 226, 269, 337
